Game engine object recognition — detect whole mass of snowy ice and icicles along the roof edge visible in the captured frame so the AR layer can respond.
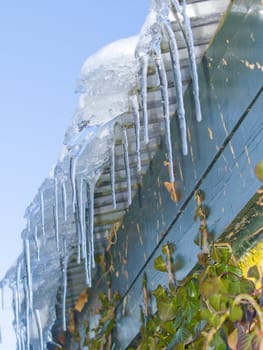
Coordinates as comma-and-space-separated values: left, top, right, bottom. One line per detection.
1, 0, 204, 350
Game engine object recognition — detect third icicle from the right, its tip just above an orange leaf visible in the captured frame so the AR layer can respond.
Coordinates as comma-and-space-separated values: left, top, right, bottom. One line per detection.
155, 48, 175, 182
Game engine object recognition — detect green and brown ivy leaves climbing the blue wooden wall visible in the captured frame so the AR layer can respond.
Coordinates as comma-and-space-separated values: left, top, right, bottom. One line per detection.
67, 191, 263, 350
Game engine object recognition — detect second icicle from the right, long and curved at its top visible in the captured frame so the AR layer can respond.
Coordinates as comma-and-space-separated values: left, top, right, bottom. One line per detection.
162, 21, 188, 155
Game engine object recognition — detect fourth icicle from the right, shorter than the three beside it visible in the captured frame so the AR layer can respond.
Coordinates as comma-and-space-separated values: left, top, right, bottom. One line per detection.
139, 54, 149, 144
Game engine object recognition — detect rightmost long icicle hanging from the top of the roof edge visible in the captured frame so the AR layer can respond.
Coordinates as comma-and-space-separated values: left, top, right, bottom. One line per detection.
182, 0, 202, 122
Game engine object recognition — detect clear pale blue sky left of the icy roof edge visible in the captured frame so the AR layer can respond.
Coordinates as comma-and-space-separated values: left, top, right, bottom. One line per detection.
0, 0, 150, 350
